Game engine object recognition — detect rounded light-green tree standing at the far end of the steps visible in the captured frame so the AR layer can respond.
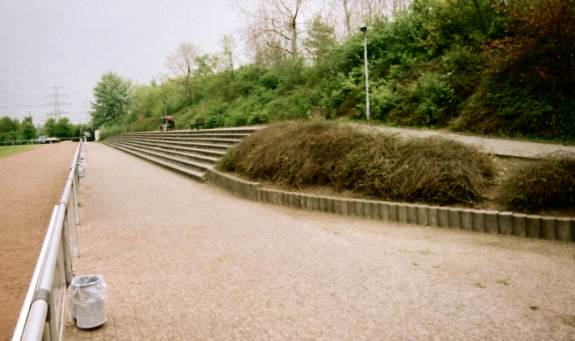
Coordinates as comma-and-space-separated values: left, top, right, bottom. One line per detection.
92, 72, 131, 128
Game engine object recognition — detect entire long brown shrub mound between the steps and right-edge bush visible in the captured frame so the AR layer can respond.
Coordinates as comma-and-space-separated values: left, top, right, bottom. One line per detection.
221, 122, 494, 204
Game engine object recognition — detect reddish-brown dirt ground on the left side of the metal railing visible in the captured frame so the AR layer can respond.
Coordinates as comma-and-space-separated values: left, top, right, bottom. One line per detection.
0, 142, 76, 340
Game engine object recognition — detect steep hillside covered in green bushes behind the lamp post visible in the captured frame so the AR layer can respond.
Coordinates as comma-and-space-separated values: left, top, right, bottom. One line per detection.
117, 0, 575, 141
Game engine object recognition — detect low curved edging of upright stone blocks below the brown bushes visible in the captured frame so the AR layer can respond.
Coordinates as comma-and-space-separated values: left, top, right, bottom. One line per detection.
206, 169, 575, 242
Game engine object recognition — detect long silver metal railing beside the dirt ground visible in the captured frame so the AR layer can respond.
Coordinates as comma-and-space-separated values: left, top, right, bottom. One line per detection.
12, 141, 85, 341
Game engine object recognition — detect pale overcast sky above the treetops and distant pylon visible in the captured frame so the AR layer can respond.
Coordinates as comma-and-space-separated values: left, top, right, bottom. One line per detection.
0, 0, 253, 123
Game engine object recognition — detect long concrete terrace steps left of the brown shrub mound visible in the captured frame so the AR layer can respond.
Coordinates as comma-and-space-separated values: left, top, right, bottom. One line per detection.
104, 127, 259, 181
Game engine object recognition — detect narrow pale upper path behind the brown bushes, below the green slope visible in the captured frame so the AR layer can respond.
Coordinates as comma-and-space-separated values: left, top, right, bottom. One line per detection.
362, 125, 575, 158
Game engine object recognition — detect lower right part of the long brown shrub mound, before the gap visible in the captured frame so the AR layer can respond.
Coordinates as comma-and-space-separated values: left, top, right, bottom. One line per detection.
340, 137, 494, 204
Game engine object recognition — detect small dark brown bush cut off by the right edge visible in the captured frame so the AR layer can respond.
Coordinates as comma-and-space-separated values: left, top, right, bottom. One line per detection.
497, 155, 575, 213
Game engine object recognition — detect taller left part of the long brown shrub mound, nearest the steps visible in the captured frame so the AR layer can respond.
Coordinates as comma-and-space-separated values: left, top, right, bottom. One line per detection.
222, 121, 374, 188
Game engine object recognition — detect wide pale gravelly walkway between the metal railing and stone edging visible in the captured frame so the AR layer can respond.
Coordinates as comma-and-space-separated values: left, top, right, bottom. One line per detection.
65, 144, 575, 340
